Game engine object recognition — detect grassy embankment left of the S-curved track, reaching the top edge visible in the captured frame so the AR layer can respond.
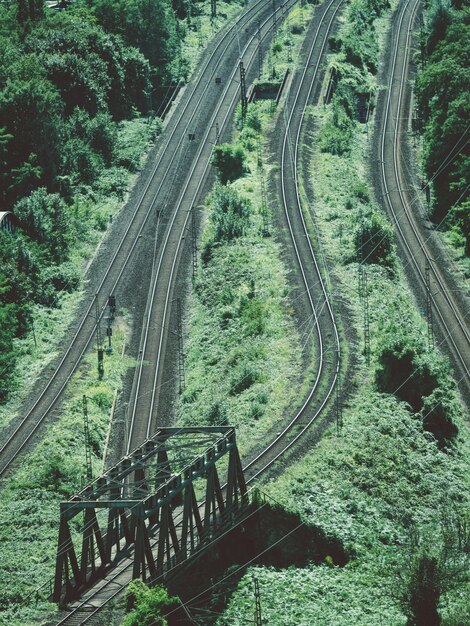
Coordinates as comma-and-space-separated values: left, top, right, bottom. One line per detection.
179, 2, 313, 454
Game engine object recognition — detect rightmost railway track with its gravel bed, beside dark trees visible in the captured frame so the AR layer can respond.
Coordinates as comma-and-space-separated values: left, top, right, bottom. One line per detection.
376, 0, 470, 404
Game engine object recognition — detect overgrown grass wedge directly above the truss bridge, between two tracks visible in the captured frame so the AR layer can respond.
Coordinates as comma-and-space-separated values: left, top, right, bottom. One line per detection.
180, 103, 302, 453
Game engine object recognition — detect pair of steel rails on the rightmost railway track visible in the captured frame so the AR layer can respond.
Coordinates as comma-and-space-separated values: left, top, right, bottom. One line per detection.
380, 0, 470, 385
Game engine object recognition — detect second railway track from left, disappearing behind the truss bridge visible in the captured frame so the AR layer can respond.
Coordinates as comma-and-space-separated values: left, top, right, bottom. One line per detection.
125, 0, 302, 454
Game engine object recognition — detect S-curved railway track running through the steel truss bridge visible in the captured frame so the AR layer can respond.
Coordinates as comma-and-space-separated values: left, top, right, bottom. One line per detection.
50, 0, 344, 626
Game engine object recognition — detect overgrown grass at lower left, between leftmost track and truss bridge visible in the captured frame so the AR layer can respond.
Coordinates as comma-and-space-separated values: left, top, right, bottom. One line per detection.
0, 318, 132, 626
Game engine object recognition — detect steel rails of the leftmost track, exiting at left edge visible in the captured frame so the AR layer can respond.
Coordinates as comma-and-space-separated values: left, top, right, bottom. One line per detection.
0, 0, 280, 477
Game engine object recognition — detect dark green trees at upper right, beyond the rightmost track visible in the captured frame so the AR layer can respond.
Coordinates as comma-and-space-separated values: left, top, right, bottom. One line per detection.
416, 2, 470, 251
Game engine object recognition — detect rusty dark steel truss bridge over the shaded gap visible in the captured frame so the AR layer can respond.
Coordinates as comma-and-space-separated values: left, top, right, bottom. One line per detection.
52, 426, 249, 604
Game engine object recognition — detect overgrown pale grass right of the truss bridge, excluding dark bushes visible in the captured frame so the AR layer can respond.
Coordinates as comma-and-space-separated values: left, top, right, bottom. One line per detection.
218, 112, 470, 626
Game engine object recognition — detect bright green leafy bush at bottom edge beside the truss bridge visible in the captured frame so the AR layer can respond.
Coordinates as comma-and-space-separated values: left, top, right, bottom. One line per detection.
123, 580, 178, 626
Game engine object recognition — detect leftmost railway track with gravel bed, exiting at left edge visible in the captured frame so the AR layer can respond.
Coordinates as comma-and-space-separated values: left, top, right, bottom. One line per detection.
0, 0, 281, 478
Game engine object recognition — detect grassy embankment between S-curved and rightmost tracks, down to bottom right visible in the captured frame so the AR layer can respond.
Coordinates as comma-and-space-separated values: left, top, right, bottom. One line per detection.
217, 2, 470, 626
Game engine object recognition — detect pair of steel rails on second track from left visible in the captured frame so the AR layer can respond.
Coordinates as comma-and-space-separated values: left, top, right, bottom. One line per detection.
126, 0, 297, 454
